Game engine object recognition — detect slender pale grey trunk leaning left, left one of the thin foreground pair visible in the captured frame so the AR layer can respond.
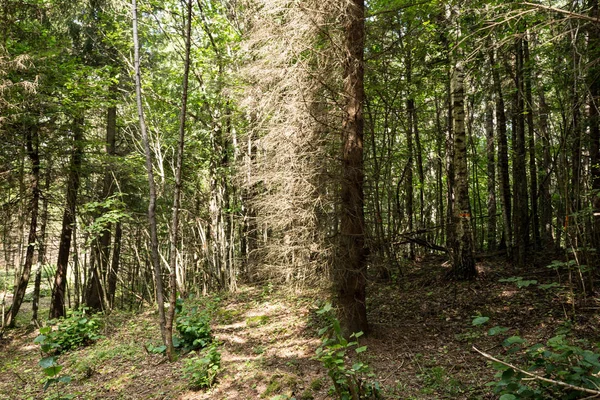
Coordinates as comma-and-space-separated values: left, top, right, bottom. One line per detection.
131, 0, 167, 345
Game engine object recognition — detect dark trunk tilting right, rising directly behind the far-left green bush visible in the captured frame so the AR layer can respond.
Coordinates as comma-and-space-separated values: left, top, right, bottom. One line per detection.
50, 117, 83, 318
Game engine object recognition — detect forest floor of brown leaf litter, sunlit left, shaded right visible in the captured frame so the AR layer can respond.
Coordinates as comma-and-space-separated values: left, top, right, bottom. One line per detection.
0, 258, 600, 400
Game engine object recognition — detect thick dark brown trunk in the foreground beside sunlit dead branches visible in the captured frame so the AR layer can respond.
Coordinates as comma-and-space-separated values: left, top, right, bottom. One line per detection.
334, 0, 369, 334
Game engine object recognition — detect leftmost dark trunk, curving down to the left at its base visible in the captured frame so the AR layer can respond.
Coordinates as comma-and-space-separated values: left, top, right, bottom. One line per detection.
6, 126, 40, 327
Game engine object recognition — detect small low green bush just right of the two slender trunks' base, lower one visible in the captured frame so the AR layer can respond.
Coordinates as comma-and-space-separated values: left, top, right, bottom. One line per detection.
183, 343, 221, 389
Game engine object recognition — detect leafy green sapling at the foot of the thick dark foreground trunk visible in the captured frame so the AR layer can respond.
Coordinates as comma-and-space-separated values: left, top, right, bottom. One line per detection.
314, 303, 381, 400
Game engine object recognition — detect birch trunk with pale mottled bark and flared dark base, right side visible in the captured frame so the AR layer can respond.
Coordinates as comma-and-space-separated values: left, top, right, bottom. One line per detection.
452, 65, 477, 280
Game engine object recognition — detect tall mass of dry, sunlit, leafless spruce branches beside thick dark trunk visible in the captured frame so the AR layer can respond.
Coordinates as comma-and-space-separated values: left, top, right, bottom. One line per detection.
237, 0, 354, 281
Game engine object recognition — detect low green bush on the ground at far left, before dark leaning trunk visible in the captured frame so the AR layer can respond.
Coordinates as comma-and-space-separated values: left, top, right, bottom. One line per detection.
34, 307, 101, 354
